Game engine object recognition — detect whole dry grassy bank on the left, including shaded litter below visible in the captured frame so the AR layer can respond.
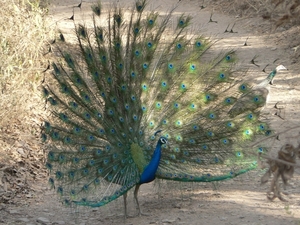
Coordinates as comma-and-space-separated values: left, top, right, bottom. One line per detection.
0, 0, 54, 204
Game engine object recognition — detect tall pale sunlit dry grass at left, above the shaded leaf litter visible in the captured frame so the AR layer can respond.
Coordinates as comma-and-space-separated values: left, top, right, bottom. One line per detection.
0, 0, 51, 163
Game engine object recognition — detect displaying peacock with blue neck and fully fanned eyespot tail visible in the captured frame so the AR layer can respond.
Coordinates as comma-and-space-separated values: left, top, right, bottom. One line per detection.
42, 0, 271, 216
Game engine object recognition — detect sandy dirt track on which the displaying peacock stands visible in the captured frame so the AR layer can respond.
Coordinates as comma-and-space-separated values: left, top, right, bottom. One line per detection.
0, 0, 300, 225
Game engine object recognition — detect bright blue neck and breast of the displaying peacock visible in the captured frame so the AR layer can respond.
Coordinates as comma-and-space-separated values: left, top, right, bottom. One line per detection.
140, 141, 162, 184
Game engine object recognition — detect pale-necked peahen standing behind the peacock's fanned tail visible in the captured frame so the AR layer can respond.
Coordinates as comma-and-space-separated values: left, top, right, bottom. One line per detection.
229, 65, 286, 117
